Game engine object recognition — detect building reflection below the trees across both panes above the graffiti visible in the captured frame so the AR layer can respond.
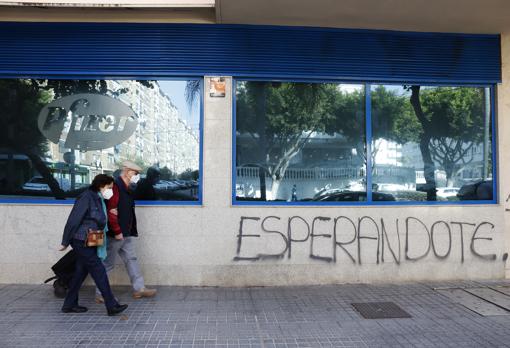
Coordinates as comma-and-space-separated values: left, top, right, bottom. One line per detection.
236, 129, 491, 198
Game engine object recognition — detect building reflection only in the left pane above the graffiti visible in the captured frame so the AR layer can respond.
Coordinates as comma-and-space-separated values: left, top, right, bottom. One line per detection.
236, 133, 365, 200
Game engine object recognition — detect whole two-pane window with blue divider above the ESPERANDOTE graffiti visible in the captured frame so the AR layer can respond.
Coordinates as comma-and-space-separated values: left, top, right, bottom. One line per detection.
235, 81, 494, 204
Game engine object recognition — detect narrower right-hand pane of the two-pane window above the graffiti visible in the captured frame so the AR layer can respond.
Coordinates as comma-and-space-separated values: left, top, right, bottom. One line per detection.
371, 85, 493, 201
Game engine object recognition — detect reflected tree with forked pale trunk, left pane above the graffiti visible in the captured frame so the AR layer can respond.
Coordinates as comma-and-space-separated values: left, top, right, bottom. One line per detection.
236, 82, 336, 199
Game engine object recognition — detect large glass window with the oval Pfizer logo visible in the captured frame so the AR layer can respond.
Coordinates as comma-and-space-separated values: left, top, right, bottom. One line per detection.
0, 79, 201, 201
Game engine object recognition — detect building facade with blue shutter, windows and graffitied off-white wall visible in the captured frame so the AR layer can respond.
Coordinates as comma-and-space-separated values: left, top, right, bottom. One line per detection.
0, 1, 510, 286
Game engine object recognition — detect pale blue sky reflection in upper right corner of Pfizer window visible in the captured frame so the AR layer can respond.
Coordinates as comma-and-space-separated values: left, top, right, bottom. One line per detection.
158, 80, 200, 130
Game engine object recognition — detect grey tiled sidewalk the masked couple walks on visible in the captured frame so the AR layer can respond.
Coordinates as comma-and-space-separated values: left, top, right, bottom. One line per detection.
0, 281, 510, 348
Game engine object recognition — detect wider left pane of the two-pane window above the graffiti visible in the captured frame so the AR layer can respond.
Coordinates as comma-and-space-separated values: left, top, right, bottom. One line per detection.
235, 81, 366, 201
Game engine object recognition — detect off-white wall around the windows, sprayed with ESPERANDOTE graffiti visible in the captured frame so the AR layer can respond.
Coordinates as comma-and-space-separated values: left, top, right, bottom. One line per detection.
0, 51, 510, 286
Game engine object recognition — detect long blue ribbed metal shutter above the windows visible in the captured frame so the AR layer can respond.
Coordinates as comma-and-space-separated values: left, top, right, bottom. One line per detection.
0, 22, 501, 83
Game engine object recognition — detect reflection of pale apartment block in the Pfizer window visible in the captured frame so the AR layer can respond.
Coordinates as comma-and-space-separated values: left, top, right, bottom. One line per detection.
48, 80, 199, 182
